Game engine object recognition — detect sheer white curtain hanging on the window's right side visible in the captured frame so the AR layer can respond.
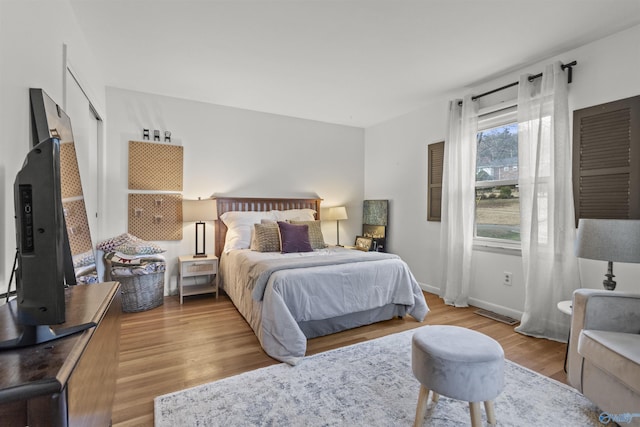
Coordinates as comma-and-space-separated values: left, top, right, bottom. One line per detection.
516, 62, 580, 341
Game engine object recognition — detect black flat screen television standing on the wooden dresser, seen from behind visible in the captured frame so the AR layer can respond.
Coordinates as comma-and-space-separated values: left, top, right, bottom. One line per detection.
13, 138, 71, 325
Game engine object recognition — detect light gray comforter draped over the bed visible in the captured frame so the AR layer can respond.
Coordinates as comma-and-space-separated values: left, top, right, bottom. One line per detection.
219, 248, 429, 365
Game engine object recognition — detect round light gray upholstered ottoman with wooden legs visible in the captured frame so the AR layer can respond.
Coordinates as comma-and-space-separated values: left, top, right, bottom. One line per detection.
411, 325, 504, 427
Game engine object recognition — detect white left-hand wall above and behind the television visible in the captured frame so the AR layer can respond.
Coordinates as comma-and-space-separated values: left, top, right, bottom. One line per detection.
0, 0, 104, 298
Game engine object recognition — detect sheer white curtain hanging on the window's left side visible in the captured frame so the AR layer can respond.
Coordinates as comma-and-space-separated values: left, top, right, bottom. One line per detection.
440, 95, 478, 307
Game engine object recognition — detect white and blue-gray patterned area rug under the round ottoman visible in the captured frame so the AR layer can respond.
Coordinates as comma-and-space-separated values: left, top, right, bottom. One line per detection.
154, 326, 601, 427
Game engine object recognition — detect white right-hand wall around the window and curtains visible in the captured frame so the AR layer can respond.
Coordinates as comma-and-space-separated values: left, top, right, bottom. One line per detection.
365, 22, 640, 317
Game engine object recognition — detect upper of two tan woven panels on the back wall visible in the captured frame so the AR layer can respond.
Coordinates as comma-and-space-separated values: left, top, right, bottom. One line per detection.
129, 141, 183, 191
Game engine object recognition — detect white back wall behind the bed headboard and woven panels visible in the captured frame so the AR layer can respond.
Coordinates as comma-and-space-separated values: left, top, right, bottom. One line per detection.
105, 88, 364, 292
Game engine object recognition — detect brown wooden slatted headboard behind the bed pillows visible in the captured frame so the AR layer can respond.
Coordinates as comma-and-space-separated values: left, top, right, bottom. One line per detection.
214, 197, 322, 257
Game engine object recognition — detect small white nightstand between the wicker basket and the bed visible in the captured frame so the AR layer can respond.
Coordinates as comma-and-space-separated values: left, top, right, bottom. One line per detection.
178, 255, 218, 304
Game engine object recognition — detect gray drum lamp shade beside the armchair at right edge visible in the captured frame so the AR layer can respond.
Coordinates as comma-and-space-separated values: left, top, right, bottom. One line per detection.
575, 218, 640, 263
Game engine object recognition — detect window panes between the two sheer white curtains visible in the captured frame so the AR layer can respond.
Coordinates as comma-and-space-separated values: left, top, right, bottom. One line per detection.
475, 107, 520, 244
